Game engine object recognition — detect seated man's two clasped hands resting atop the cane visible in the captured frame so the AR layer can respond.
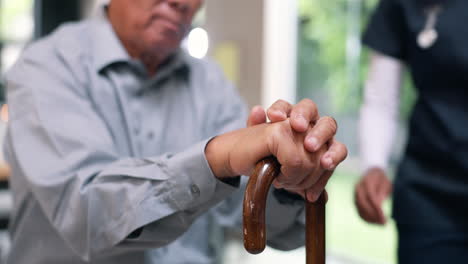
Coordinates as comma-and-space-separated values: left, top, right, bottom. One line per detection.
205, 99, 347, 202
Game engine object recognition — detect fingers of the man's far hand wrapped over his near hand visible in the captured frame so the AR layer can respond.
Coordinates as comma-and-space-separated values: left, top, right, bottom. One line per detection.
247, 99, 347, 202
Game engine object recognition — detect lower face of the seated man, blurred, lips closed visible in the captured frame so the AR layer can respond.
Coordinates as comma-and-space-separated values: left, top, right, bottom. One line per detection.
108, 0, 203, 60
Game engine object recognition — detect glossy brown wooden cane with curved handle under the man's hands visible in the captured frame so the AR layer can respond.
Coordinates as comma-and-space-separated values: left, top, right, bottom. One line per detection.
243, 157, 325, 264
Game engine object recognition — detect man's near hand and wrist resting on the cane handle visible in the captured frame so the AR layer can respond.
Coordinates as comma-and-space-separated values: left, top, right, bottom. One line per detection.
205, 119, 331, 201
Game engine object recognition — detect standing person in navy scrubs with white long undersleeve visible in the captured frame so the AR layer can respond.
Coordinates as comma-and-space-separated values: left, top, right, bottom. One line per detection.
355, 0, 468, 264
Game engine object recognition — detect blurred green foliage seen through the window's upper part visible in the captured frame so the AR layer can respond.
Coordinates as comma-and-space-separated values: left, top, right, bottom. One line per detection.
298, 0, 415, 117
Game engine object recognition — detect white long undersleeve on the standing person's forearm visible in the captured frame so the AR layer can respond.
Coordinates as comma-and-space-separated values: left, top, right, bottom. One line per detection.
359, 53, 403, 172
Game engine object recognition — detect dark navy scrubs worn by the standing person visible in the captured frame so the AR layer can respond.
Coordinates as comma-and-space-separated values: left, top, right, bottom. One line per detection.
364, 0, 468, 264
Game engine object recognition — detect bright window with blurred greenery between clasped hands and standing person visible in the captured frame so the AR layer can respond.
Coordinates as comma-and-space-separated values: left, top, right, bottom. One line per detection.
297, 0, 396, 263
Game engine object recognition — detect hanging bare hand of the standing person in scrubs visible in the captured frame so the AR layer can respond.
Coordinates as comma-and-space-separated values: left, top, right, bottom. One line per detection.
354, 168, 393, 225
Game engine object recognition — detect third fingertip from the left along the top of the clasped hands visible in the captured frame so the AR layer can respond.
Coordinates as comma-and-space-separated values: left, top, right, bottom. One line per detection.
290, 99, 319, 132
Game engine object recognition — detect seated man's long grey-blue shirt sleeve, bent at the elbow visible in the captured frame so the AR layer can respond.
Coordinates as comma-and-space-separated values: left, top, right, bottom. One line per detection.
6, 46, 241, 260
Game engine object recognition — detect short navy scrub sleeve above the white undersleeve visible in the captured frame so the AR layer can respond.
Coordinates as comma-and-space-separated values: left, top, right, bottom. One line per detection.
363, 0, 409, 60
